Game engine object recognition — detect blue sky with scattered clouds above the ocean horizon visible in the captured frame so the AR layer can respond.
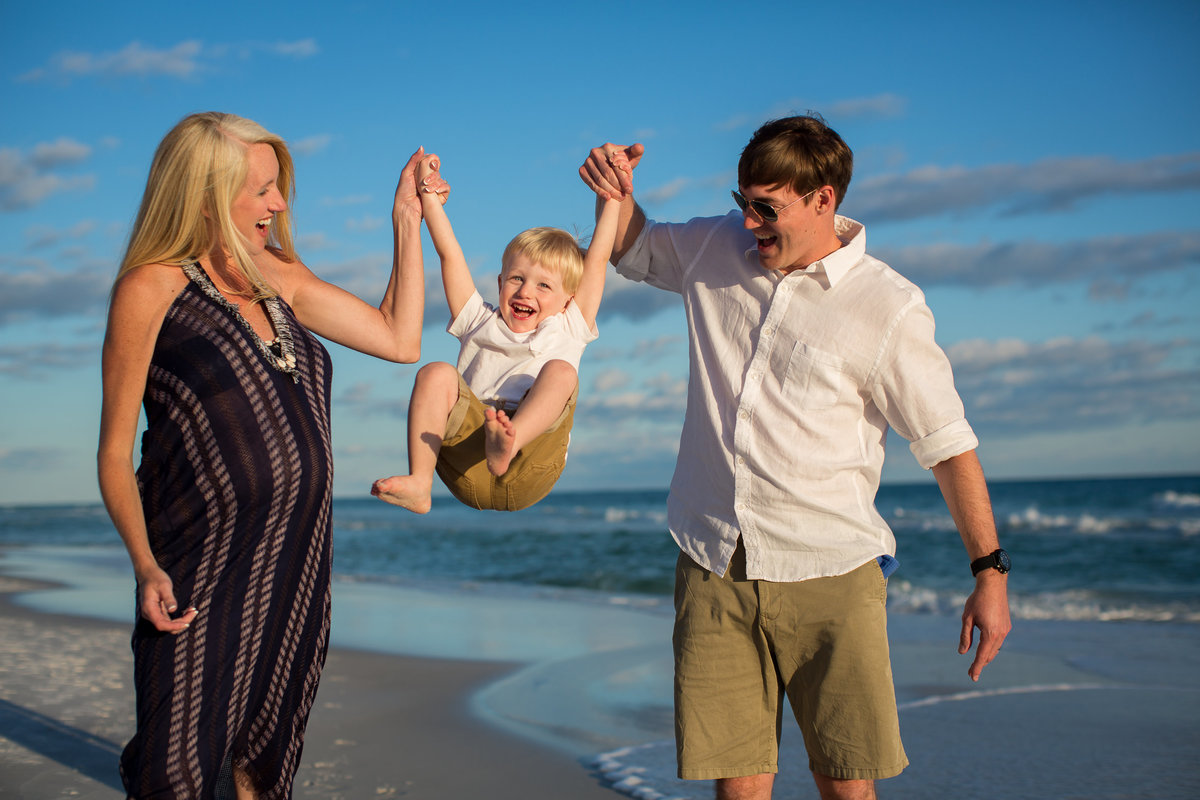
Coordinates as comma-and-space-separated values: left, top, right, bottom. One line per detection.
0, 0, 1200, 503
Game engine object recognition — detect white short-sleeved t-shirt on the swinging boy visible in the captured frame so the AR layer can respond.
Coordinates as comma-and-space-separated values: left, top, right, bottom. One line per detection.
446, 291, 599, 404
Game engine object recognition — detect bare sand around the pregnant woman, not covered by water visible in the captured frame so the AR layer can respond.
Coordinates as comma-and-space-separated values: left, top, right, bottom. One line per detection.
0, 571, 622, 800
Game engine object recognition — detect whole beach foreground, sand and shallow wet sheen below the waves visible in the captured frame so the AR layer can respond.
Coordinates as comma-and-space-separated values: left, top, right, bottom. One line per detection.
0, 548, 1200, 800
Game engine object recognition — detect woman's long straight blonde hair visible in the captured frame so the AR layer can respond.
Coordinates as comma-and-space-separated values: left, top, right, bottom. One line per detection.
118, 112, 296, 300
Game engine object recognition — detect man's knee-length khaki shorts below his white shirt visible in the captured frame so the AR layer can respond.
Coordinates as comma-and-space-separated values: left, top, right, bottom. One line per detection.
673, 541, 908, 780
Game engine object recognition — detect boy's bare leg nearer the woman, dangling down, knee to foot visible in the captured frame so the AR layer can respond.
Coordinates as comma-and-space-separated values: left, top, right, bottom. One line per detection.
371, 361, 458, 513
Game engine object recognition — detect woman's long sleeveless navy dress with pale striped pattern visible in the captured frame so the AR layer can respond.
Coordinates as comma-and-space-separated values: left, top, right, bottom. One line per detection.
121, 265, 332, 799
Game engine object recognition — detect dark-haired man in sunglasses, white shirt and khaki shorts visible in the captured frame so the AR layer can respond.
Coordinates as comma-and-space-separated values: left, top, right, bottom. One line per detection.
580, 116, 1010, 800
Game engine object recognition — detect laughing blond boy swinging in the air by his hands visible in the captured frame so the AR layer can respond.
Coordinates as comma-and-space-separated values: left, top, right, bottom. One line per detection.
371, 155, 629, 513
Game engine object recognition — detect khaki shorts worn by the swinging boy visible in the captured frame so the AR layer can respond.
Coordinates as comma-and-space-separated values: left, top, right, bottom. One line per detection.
437, 375, 580, 511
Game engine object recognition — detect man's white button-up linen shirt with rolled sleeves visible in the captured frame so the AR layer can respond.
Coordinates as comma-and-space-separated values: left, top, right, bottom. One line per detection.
617, 211, 978, 582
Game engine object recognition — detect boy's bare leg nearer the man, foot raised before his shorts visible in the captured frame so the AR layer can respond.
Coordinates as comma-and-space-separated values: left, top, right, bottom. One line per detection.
484, 360, 578, 476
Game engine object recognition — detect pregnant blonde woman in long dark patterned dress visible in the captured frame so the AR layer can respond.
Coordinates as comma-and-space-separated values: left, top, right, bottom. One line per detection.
98, 113, 436, 799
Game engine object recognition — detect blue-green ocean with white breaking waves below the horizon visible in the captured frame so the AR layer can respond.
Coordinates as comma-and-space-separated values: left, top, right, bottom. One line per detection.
0, 476, 1200, 624
